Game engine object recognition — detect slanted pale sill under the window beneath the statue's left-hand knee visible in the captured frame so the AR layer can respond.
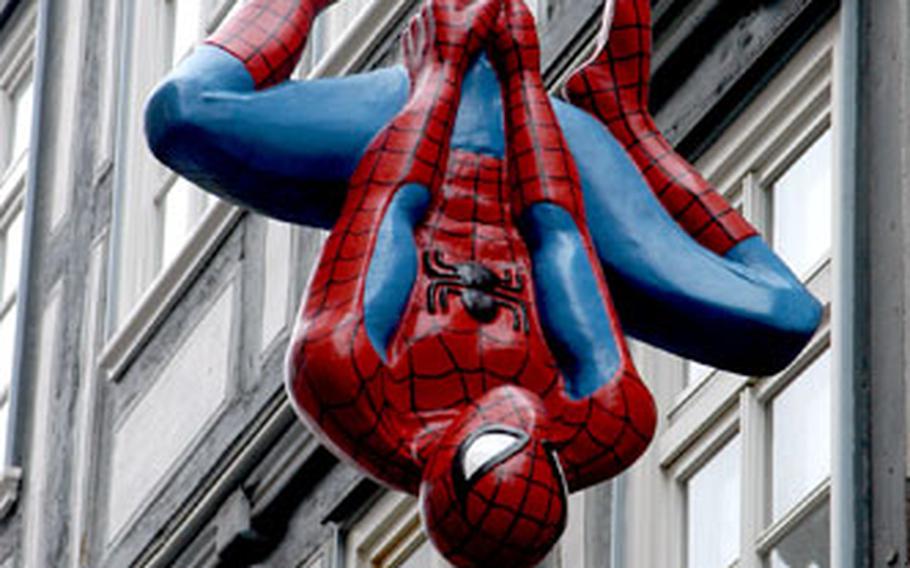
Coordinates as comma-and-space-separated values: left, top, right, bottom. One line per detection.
100, 201, 243, 381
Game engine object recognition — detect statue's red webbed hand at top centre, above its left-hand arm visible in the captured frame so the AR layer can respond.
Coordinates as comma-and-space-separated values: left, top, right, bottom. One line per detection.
402, 0, 503, 80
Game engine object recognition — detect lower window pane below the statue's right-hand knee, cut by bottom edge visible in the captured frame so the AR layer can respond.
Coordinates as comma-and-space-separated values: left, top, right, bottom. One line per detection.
686, 436, 741, 568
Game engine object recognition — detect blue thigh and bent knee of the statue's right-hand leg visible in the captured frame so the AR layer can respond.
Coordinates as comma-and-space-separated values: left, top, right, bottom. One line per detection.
556, 103, 822, 375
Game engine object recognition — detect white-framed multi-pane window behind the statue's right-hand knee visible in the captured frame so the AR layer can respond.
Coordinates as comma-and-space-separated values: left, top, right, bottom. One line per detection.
626, 18, 838, 568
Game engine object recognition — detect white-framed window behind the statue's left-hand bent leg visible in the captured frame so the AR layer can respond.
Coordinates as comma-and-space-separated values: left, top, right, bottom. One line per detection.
108, 0, 396, 350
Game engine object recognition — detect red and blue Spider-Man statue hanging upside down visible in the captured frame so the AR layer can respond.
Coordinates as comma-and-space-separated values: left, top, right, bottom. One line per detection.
146, 0, 821, 567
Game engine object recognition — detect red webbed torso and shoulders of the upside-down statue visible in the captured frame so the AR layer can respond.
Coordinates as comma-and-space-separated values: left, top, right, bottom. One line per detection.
290, 146, 655, 493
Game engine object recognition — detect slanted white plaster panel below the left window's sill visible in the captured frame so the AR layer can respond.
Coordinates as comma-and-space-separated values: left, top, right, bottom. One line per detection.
107, 284, 234, 539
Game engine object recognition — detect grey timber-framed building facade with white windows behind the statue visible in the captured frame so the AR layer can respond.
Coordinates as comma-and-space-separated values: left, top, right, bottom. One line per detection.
0, 0, 910, 568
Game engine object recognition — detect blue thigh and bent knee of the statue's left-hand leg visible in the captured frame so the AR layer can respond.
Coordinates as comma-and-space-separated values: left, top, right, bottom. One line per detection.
145, 45, 408, 227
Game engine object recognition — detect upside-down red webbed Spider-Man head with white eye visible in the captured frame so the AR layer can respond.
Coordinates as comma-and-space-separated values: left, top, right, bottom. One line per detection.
420, 387, 567, 566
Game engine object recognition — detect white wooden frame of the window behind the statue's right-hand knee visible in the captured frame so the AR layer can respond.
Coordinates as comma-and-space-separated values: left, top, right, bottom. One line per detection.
652, 17, 838, 568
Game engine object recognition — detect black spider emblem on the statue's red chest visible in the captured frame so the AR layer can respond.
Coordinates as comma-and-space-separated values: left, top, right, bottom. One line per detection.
423, 250, 529, 333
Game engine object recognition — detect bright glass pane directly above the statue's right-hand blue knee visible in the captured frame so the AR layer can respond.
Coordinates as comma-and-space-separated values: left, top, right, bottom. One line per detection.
772, 130, 833, 276
